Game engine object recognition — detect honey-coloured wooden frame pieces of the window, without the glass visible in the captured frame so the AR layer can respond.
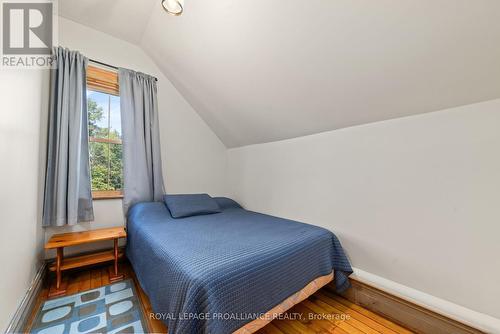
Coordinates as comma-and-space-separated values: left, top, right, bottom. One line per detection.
86, 64, 123, 200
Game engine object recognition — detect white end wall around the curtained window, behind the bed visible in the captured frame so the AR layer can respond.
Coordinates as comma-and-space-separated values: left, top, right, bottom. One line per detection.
46, 17, 226, 257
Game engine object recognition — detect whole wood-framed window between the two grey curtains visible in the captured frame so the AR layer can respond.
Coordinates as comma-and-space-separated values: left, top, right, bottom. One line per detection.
87, 66, 123, 199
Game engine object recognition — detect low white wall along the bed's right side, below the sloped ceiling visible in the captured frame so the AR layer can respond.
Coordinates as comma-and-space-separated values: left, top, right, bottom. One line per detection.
228, 100, 500, 318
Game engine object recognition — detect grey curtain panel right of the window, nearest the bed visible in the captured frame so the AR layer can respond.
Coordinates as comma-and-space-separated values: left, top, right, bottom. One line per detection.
118, 68, 165, 214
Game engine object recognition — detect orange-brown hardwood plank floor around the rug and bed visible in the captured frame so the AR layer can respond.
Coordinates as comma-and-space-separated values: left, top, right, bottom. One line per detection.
26, 260, 412, 334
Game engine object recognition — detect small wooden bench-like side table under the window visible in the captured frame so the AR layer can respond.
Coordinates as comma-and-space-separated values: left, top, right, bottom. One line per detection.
45, 227, 127, 297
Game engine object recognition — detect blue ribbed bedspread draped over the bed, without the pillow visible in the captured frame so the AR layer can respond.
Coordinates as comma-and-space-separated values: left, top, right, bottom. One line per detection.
127, 198, 352, 334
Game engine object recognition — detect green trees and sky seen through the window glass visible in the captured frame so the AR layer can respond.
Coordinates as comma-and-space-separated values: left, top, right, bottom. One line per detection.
87, 90, 123, 193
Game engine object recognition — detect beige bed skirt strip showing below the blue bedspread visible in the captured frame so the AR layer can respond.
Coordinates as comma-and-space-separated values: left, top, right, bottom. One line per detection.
234, 271, 333, 334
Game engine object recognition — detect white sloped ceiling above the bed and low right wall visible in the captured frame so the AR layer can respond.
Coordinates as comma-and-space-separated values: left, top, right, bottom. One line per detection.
60, 0, 500, 147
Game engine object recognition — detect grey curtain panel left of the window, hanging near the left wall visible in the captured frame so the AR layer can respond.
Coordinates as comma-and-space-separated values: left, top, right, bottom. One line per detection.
43, 47, 94, 226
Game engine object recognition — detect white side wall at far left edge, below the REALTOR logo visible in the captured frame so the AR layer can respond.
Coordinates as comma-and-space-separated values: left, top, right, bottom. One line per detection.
0, 69, 48, 332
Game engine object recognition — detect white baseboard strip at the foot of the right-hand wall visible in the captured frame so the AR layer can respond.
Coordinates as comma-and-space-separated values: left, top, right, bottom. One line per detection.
353, 268, 500, 334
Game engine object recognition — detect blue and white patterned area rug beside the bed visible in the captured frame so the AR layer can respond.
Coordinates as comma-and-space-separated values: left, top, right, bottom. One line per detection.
31, 279, 147, 334
